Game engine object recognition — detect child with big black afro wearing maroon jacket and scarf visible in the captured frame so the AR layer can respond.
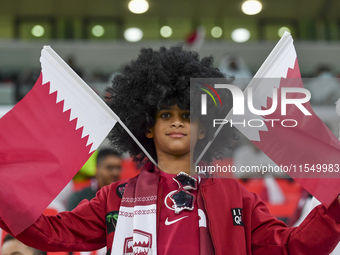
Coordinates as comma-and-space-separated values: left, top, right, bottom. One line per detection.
0, 46, 340, 255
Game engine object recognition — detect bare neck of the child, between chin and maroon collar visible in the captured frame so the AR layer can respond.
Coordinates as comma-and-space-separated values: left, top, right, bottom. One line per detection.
157, 153, 194, 174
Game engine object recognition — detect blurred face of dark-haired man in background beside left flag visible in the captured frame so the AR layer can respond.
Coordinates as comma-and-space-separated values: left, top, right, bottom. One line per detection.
96, 155, 122, 188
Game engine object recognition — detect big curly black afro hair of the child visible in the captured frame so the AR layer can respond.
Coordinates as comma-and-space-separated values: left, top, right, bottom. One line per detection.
107, 45, 234, 162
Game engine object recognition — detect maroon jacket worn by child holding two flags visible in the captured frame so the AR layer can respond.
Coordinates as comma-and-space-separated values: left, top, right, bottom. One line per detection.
0, 163, 340, 255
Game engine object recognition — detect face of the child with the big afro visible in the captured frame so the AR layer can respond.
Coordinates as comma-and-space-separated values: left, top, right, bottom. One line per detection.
146, 105, 205, 157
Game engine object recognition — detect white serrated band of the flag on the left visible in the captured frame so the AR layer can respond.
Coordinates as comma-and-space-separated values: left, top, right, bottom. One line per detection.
40, 46, 119, 152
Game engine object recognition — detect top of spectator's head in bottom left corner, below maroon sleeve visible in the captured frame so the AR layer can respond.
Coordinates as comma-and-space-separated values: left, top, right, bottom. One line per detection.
1, 235, 47, 255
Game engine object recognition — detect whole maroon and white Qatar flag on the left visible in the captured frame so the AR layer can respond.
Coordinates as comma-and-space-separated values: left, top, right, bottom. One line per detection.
0, 46, 119, 235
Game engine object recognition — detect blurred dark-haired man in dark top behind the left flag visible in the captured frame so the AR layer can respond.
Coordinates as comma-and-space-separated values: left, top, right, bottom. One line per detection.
67, 149, 122, 211
